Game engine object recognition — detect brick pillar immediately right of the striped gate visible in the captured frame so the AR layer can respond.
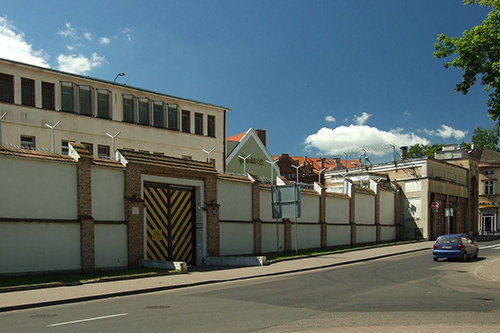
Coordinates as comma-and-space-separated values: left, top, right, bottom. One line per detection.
205, 175, 220, 257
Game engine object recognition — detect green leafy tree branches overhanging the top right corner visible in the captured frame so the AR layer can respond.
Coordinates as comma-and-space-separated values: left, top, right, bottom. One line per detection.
434, 0, 500, 121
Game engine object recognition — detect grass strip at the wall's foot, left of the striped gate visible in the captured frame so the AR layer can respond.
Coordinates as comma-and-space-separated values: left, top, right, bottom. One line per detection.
0, 267, 172, 288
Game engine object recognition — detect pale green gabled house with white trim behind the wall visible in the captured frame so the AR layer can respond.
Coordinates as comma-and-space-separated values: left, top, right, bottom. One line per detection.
226, 128, 280, 180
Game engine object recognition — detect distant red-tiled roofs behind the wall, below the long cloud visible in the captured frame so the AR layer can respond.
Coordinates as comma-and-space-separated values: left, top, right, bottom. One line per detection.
274, 154, 363, 184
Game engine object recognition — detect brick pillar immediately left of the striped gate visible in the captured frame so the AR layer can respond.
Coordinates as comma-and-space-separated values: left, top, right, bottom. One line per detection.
125, 163, 145, 268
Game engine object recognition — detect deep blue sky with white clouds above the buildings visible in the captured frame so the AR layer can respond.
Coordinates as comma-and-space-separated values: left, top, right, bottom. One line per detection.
0, 0, 494, 161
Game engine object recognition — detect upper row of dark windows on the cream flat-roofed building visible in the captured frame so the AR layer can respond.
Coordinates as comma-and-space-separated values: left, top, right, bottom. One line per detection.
0, 73, 215, 137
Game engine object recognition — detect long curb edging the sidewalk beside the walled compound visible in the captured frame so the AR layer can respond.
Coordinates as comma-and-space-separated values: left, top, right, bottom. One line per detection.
0, 248, 429, 312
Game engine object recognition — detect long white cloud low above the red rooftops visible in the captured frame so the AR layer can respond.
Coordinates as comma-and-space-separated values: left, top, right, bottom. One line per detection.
304, 125, 429, 156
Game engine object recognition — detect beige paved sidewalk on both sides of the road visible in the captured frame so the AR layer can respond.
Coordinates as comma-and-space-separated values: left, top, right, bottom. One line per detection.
0, 242, 500, 312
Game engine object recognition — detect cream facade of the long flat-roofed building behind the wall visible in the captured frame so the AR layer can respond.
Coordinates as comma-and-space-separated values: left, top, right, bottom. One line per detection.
0, 59, 229, 172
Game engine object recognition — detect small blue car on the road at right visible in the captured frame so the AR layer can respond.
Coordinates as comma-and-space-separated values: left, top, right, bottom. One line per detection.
432, 234, 479, 261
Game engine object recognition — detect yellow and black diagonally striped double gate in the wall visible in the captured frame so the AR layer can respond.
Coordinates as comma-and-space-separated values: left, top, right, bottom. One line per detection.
144, 183, 196, 264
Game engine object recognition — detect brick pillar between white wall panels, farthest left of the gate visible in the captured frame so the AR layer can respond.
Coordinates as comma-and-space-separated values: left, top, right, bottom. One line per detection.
77, 152, 95, 273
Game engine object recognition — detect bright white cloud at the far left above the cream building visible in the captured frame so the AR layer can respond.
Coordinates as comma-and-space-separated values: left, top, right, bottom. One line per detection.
0, 16, 49, 67
